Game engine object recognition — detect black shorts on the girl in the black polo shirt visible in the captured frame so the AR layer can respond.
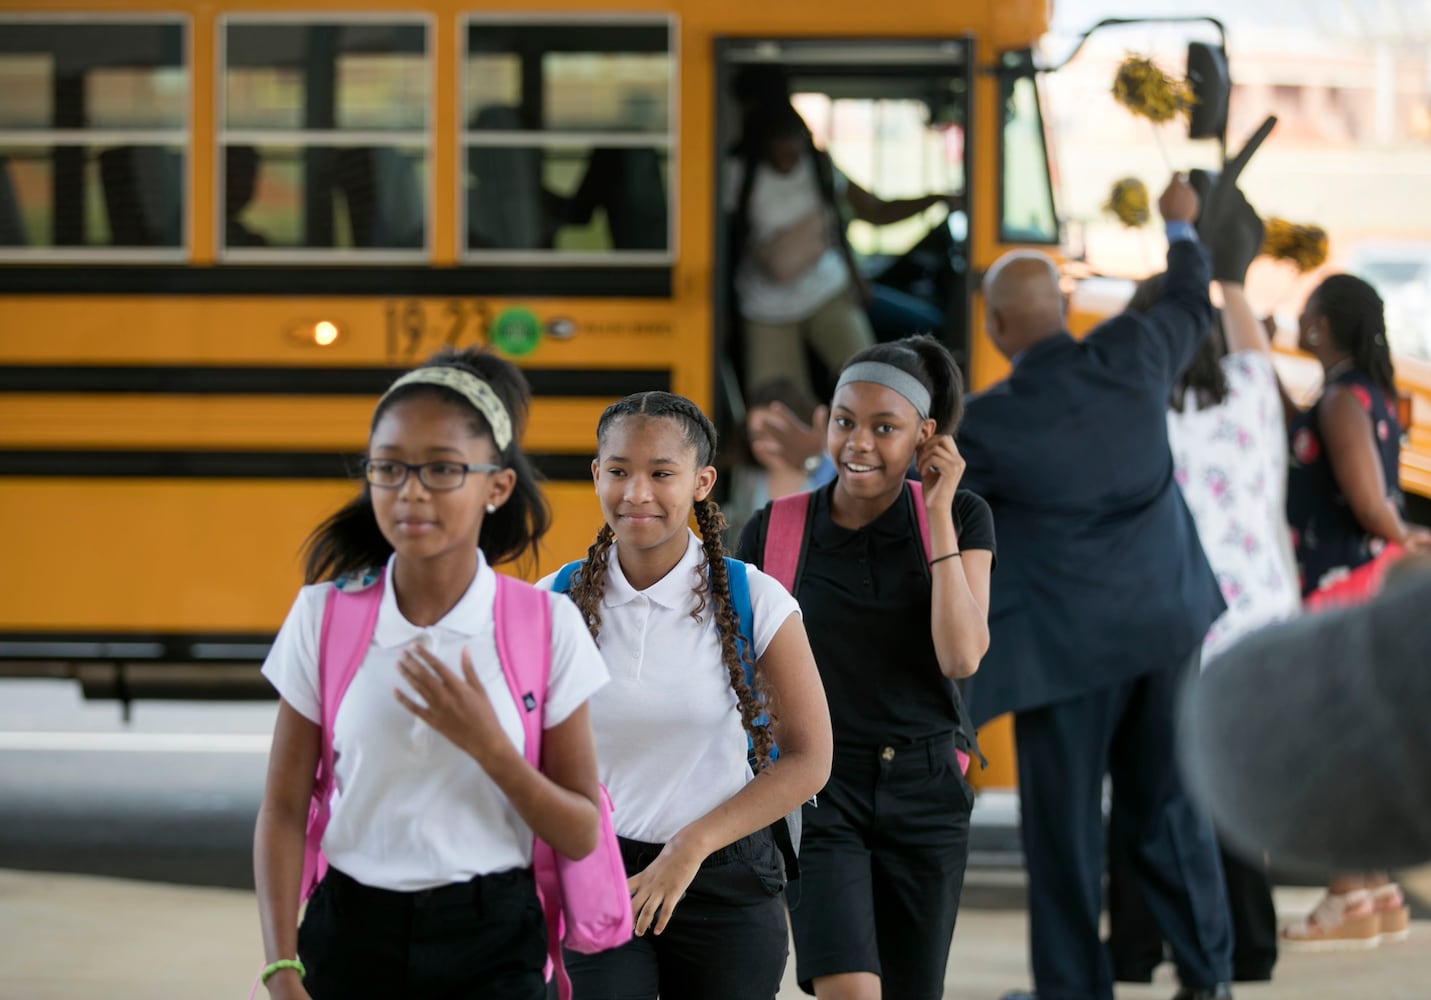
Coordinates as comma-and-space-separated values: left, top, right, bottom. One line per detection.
790, 734, 973, 1000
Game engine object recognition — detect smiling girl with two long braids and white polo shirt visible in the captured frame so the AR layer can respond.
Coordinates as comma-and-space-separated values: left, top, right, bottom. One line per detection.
539, 392, 830, 1000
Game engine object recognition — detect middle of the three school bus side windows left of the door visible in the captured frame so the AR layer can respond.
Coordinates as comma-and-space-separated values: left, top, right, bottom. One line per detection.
220, 19, 431, 262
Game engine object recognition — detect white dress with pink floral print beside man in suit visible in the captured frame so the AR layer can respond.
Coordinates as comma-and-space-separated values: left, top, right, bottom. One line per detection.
1168, 351, 1299, 664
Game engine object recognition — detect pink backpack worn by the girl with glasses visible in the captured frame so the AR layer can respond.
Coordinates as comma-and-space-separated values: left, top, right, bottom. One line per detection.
303, 571, 633, 1000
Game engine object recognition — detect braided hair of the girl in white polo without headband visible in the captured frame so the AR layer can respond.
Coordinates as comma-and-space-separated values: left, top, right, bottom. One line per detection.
571, 392, 774, 768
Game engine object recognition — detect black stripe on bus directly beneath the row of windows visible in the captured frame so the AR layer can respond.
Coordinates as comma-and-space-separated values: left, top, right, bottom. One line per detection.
0, 265, 671, 299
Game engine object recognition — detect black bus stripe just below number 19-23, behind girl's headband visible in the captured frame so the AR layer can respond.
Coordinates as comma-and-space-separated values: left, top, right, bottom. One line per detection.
0, 365, 671, 398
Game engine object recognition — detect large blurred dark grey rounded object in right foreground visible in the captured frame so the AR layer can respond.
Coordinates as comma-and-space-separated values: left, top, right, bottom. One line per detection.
1179, 572, 1431, 884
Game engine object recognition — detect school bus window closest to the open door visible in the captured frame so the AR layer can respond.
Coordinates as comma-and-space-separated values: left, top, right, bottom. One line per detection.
462, 19, 673, 263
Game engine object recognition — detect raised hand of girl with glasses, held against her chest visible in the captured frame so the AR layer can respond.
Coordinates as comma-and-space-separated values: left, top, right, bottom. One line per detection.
394, 645, 515, 764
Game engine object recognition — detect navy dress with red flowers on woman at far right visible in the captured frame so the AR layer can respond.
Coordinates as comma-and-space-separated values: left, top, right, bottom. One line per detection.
1286, 369, 1404, 597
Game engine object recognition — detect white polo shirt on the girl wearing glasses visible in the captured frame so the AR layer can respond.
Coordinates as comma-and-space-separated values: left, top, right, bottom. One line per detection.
263, 552, 607, 891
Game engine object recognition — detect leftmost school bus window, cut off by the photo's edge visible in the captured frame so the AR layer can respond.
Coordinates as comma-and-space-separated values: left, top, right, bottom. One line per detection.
0, 19, 189, 262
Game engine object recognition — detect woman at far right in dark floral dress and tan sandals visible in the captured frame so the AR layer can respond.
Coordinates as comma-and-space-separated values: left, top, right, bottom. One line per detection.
1282, 275, 1431, 950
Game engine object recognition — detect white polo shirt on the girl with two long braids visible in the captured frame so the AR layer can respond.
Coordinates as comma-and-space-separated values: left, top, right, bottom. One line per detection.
537, 532, 800, 844
